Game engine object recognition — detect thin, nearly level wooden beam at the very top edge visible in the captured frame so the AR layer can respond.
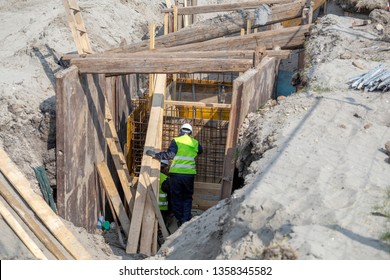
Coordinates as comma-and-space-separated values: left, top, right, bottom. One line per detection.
161, 0, 291, 15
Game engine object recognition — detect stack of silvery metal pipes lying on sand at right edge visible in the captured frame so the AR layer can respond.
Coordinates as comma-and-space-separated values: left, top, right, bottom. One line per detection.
348, 64, 390, 92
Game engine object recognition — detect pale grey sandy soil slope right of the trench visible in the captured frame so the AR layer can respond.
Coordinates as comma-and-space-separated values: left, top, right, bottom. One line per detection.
153, 15, 390, 260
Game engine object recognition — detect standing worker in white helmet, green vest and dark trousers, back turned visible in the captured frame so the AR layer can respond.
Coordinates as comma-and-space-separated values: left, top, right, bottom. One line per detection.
146, 123, 203, 226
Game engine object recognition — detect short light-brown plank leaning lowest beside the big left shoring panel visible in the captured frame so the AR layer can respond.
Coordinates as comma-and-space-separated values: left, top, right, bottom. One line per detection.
96, 161, 130, 236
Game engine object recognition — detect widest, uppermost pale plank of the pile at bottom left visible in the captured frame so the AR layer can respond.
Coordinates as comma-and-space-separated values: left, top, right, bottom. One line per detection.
0, 149, 93, 260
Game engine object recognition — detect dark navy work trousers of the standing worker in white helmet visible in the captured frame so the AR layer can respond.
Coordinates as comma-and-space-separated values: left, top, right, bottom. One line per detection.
169, 173, 195, 225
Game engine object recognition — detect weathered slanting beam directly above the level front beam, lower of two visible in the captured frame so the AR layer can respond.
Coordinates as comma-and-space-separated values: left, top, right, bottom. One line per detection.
157, 24, 312, 52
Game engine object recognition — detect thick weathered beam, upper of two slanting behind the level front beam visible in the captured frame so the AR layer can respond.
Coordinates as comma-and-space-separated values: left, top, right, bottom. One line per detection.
108, 0, 306, 52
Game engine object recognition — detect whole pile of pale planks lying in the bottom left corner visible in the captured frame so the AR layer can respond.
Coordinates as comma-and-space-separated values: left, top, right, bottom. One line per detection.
0, 149, 93, 260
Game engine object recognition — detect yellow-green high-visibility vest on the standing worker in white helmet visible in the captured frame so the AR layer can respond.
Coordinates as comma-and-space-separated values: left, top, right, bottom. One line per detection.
169, 134, 199, 174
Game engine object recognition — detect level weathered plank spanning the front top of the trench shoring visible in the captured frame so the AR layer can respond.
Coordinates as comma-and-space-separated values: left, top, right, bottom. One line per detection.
71, 57, 253, 74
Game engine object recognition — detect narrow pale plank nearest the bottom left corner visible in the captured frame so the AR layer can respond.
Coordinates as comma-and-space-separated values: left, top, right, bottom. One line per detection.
0, 201, 47, 260
